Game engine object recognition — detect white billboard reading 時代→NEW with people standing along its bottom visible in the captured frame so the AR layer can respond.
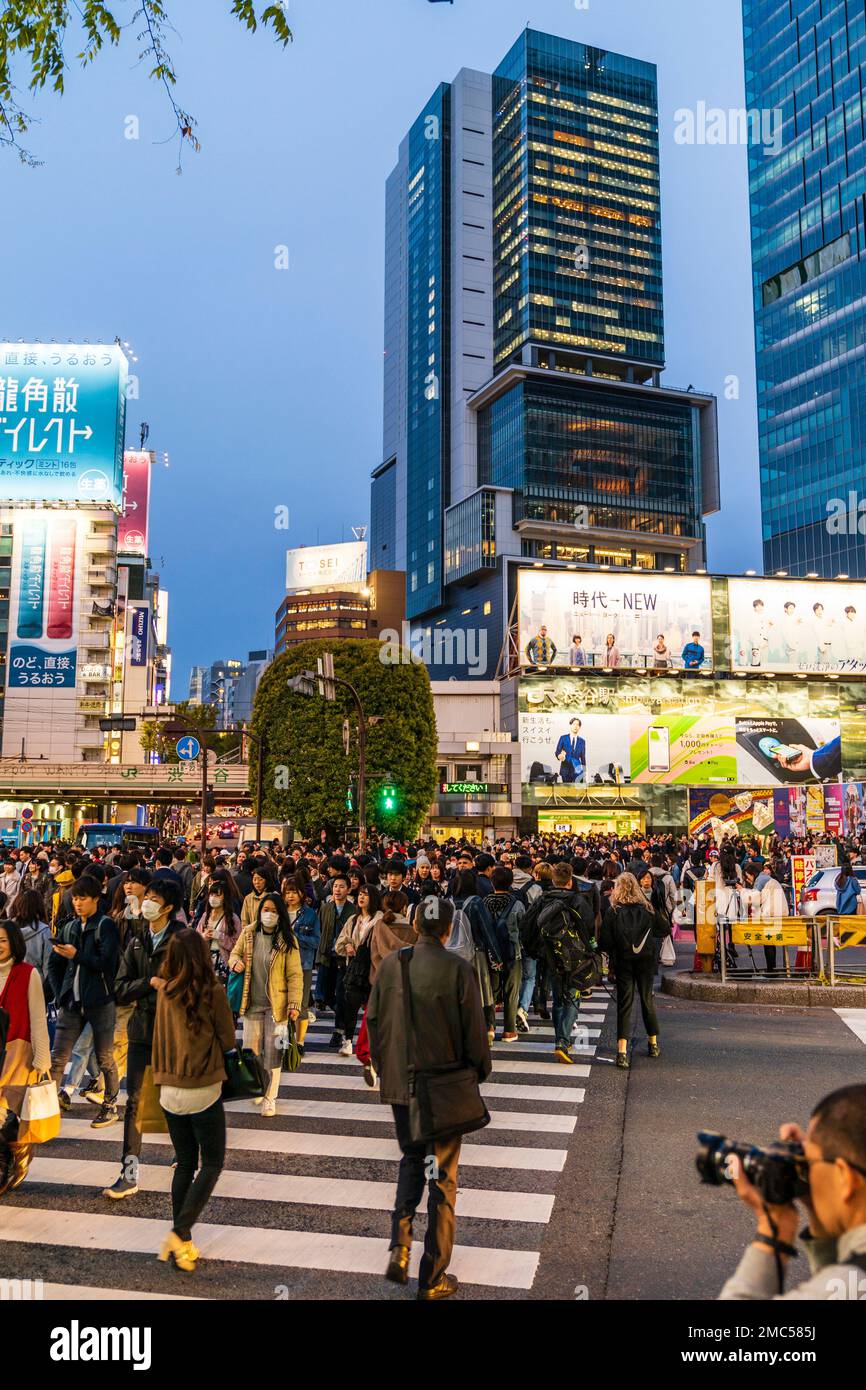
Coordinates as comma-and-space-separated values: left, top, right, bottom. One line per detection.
517, 570, 713, 671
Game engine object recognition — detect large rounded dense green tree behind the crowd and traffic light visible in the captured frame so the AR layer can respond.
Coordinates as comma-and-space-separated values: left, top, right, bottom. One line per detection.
253, 639, 436, 837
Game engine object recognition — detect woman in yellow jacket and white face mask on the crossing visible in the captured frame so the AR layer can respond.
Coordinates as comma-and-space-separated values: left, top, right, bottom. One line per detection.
228, 884, 303, 1116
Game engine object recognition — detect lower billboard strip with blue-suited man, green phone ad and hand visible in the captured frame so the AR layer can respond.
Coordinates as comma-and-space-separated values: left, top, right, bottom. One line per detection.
518, 676, 842, 788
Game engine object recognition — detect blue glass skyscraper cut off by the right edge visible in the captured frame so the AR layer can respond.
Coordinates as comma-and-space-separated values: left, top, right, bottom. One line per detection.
742, 0, 866, 578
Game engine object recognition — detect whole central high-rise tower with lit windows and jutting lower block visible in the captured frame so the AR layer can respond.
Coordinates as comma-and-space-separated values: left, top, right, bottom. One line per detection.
370, 29, 719, 677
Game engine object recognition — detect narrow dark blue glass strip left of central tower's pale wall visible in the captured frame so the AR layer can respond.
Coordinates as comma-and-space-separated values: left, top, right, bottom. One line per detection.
406, 83, 450, 619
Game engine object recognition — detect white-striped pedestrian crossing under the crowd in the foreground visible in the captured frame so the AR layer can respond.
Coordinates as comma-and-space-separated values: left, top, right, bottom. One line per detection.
0, 995, 610, 1301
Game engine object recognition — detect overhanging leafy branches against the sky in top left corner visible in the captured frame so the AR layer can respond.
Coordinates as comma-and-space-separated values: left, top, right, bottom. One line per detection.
0, 0, 292, 172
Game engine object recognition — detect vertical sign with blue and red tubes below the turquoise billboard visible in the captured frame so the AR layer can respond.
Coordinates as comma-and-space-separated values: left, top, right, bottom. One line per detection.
7, 512, 81, 689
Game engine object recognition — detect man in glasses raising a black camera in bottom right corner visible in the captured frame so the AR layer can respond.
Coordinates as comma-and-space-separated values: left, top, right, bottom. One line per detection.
719, 1086, 866, 1301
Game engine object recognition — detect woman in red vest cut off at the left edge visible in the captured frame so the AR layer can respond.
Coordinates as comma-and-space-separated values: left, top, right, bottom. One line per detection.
0, 922, 51, 1197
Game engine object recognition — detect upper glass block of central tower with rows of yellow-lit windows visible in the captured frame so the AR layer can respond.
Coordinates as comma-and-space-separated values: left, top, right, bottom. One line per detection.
493, 29, 664, 367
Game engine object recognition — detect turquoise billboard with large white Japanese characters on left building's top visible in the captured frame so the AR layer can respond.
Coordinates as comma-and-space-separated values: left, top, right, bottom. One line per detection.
0, 343, 126, 506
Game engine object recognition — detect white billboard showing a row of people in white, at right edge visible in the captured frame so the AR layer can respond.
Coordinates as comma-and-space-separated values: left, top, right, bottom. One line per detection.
728, 580, 866, 674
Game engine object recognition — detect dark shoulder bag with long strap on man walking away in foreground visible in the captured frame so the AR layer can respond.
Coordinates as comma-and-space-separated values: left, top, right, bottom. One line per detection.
400, 947, 491, 1144
